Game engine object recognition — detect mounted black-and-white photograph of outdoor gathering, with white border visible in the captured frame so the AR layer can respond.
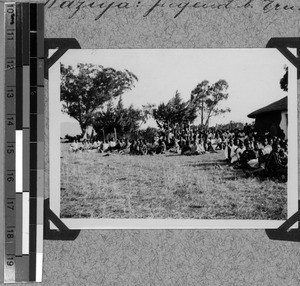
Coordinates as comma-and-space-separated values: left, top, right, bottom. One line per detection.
49, 49, 298, 228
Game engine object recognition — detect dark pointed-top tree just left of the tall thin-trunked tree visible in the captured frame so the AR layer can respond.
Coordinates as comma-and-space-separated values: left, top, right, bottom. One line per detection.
153, 91, 197, 128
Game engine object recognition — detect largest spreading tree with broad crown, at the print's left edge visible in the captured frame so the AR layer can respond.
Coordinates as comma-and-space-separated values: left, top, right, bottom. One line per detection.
60, 64, 138, 134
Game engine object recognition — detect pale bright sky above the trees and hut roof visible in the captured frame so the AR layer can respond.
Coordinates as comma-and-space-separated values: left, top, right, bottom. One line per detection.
61, 49, 288, 130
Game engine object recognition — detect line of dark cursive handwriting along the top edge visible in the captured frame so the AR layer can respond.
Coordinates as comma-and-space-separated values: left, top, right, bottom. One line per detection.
45, 0, 300, 21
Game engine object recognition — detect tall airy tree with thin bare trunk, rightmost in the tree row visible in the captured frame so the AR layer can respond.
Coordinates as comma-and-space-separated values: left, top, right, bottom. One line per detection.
191, 79, 230, 127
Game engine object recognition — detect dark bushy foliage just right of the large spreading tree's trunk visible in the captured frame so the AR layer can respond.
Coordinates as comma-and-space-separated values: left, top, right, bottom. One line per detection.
93, 97, 144, 136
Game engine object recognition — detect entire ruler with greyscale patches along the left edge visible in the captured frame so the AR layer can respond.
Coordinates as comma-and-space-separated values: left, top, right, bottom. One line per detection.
4, 2, 44, 283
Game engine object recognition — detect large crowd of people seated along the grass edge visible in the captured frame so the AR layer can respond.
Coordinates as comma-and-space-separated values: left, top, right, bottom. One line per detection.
70, 125, 287, 181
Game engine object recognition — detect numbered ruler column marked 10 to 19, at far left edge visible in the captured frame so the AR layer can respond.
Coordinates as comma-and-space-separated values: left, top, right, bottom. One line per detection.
4, 3, 16, 282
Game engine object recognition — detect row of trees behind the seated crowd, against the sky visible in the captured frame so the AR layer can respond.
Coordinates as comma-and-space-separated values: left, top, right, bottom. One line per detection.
61, 64, 230, 137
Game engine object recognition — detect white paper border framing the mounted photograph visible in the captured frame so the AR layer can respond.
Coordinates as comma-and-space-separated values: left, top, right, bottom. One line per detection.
48, 49, 298, 229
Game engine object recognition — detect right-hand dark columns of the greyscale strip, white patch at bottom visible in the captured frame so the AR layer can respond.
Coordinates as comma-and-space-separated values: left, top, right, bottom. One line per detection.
30, 3, 45, 281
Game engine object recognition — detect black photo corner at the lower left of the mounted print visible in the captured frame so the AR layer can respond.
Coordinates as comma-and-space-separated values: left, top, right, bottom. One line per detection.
44, 198, 80, 240
